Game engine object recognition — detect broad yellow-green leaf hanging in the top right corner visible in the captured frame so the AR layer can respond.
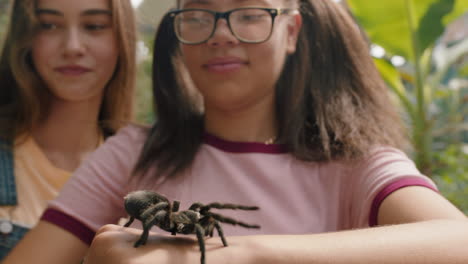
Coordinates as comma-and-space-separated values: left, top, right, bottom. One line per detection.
348, 0, 468, 60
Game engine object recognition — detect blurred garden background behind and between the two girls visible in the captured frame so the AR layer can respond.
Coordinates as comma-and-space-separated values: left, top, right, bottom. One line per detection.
0, 0, 468, 214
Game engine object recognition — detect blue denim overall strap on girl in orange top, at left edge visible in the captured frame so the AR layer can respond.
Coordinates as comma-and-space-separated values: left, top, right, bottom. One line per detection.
0, 139, 17, 206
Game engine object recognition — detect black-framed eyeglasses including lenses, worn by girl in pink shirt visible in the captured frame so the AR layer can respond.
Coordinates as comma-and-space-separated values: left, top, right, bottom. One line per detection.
169, 7, 299, 45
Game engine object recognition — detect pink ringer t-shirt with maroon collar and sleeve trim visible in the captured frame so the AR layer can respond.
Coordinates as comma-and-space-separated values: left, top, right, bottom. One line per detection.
42, 126, 437, 244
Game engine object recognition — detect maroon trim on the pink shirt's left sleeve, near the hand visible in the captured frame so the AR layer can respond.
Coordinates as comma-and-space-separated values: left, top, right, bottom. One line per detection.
41, 208, 96, 245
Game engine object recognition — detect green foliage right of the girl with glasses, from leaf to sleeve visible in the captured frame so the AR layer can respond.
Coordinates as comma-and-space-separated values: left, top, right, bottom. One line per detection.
347, 0, 468, 210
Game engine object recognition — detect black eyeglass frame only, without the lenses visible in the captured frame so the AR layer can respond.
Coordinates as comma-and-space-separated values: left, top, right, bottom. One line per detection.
168, 7, 299, 45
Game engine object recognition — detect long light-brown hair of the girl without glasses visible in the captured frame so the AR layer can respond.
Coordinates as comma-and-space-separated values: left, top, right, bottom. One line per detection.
0, 0, 136, 140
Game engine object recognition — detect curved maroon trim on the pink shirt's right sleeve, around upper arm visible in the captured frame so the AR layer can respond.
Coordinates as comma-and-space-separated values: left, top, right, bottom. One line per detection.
369, 178, 439, 227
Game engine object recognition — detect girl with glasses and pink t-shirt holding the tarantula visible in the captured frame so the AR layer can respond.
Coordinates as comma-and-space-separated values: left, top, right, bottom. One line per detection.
6, 0, 468, 264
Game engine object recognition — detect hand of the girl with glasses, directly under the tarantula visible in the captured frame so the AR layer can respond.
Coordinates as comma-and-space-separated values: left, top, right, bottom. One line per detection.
84, 225, 229, 264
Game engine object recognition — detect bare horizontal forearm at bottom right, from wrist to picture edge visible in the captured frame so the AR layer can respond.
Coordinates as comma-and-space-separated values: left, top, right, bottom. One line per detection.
238, 220, 468, 264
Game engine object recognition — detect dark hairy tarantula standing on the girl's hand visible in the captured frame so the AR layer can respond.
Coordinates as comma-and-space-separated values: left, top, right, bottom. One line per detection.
124, 191, 260, 264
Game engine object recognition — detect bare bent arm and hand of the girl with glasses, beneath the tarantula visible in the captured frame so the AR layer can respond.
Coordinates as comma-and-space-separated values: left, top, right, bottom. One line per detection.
86, 187, 468, 264
